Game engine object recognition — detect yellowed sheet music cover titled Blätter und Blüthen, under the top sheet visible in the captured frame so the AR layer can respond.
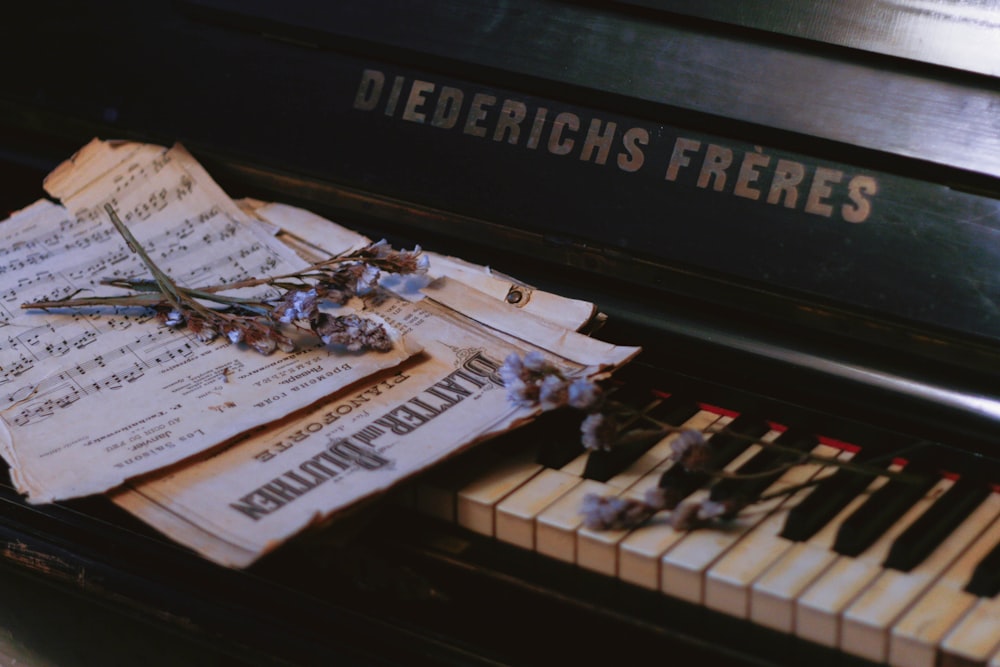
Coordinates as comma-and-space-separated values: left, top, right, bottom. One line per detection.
112, 205, 638, 567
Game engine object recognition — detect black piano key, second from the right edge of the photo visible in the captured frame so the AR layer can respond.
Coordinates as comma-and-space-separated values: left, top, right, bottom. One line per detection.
882, 474, 992, 572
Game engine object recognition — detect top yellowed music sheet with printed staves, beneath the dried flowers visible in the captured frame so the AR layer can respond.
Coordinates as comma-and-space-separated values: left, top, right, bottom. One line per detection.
0, 140, 417, 502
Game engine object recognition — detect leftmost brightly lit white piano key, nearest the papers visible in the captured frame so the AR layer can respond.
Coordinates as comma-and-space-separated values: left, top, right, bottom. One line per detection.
456, 450, 543, 537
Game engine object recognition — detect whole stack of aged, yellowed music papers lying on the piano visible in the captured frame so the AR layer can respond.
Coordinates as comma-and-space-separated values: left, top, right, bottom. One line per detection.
0, 140, 637, 566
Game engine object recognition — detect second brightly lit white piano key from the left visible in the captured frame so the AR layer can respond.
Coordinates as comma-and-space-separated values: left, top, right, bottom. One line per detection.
496, 468, 583, 550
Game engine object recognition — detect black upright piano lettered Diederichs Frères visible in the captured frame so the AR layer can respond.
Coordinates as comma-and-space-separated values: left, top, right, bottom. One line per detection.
0, 0, 1000, 667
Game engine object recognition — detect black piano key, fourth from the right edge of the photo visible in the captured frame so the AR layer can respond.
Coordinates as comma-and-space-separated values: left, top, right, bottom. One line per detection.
781, 449, 890, 542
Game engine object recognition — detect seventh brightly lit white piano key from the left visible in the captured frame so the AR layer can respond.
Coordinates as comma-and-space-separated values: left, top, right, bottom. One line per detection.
705, 445, 852, 618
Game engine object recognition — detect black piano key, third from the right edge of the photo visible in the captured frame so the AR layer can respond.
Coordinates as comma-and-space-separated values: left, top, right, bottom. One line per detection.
833, 466, 938, 556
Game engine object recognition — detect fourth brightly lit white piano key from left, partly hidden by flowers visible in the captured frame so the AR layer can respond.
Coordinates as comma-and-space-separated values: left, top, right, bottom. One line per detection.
576, 410, 732, 577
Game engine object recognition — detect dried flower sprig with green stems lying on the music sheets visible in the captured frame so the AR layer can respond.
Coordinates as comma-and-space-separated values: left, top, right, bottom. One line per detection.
21, 204, 428, 354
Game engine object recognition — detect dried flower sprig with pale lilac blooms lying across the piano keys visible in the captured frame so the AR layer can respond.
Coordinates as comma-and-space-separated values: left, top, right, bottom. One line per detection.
500, 352, 936, 530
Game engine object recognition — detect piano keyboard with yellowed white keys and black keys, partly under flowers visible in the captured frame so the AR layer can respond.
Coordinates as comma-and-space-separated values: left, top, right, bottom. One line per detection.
411, 398, 1000, 667
